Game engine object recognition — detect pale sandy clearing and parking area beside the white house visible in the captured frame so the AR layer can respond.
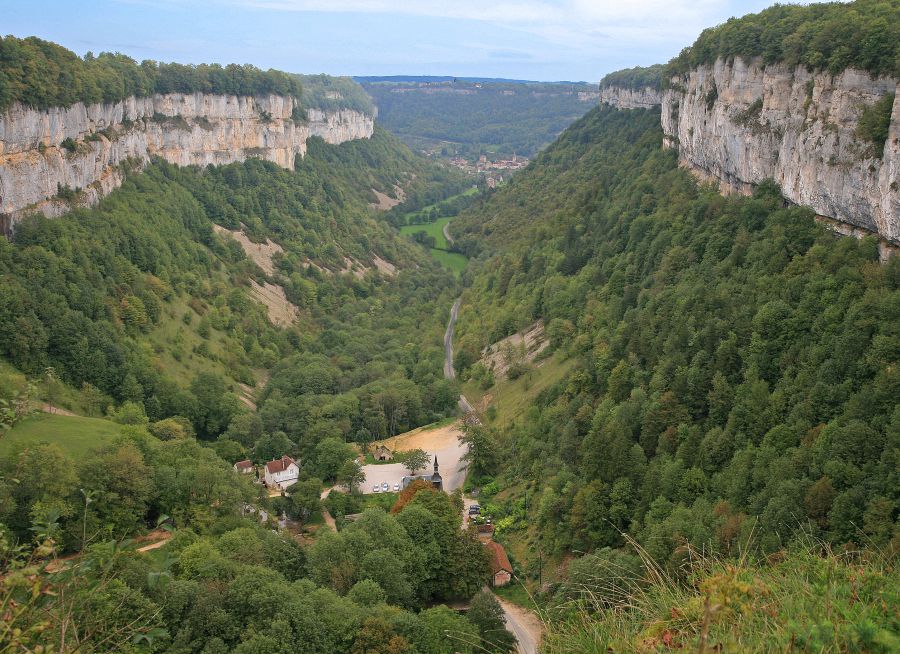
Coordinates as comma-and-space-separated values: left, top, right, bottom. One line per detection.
362, 422, 467, 494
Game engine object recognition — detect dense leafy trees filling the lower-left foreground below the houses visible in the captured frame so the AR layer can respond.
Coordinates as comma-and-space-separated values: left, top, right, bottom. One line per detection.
0, 428, 509, 654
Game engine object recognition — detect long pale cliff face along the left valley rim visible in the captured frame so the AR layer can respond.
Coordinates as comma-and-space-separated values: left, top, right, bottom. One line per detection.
0, 93, 374, 228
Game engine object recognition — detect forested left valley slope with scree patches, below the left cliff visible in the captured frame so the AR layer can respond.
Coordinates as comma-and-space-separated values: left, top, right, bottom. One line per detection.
0, 130, 464, 451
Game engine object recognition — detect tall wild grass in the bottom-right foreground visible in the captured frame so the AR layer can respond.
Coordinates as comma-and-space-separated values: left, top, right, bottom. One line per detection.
542, 548, 900, 654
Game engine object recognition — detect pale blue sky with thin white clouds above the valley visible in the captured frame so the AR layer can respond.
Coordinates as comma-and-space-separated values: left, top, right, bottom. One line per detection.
0, 0, 774, 82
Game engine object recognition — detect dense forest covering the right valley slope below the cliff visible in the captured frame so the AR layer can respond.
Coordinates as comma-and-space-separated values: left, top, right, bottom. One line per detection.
451, 108, 900, 651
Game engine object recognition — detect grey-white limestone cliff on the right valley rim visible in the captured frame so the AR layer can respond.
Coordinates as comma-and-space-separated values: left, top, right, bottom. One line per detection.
607, 58, 900, 244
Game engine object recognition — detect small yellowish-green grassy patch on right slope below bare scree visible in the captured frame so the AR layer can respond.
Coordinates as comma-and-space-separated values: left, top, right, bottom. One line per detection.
462, 355, 575, 426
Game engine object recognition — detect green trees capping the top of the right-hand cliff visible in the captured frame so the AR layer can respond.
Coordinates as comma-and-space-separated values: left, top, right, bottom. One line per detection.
665, 0, 900, 78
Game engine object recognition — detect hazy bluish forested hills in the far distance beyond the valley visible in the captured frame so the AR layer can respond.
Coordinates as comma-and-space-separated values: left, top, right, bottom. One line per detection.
363, 80, 596, 157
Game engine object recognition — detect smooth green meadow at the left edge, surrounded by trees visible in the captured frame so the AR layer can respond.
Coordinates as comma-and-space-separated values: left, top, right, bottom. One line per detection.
0, 413, 121, 457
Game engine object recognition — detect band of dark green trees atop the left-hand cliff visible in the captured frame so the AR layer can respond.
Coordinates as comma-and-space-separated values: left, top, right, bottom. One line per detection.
0, 36, 300, 110
